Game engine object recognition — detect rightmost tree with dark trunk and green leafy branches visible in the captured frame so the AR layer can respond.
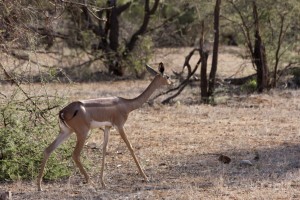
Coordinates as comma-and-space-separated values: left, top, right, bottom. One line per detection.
223, 0, 300, 92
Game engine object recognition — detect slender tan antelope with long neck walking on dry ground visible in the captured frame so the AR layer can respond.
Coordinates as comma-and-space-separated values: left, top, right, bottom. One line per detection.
37, 63, 171, 191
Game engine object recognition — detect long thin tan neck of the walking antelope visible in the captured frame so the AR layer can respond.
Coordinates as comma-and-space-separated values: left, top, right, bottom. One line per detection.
128, 75, 161, 111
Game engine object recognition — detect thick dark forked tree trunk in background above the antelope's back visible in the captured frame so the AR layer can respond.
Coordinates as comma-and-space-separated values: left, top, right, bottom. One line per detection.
77, 0, 159, 76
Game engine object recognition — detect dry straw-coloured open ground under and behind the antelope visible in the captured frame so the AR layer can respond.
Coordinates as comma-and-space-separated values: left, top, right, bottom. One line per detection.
0, 47, 300, 200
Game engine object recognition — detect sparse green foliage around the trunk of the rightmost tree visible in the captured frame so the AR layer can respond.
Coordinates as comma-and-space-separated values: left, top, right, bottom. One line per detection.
223, 0, 300, 69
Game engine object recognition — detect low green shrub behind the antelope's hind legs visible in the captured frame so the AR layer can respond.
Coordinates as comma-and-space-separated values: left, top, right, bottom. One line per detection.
0, 95, 74, 181
